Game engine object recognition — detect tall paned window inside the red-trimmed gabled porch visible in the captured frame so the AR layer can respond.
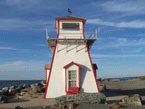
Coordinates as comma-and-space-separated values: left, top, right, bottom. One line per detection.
68, 70, 76, 87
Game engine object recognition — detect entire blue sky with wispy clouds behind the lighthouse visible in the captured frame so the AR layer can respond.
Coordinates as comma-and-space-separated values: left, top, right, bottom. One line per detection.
0, 0, 145, 80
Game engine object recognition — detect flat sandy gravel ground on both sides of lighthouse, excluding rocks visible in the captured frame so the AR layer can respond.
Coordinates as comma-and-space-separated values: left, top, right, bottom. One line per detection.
0, 80, 145, 109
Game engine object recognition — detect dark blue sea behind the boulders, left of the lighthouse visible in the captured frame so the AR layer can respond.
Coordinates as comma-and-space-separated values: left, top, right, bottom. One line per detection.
0, 80, 42, 90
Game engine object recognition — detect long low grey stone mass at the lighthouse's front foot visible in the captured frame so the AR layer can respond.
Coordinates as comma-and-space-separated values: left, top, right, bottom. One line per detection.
55, 93, 106, 105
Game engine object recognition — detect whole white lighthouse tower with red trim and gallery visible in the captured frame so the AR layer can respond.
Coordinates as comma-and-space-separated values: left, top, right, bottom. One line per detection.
44, 16, 100, 98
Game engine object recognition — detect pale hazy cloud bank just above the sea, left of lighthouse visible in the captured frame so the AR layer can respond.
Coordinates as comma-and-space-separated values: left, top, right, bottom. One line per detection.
0, 61, 47, 80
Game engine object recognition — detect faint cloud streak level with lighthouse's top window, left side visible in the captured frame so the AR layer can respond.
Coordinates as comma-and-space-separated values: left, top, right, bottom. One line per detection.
0, 19, 54, 30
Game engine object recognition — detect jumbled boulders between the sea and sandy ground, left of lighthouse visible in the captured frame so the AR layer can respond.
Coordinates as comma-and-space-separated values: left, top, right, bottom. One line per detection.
0, 81, 46, 104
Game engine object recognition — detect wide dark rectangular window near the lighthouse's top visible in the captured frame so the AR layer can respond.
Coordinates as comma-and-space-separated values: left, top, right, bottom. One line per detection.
62, 23, 80, 30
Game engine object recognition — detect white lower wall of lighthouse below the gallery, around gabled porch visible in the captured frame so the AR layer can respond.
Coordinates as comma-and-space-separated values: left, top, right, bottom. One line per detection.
46, 44, 98, 98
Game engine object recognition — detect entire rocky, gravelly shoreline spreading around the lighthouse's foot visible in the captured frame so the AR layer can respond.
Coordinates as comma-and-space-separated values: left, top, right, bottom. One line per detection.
0, 80, 145, 109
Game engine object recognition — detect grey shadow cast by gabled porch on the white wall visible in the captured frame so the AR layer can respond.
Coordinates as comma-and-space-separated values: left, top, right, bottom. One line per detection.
80, 65, 91, 93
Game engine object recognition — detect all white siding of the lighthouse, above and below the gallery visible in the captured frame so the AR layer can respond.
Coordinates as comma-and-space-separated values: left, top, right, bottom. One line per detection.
46, 21, 98, 98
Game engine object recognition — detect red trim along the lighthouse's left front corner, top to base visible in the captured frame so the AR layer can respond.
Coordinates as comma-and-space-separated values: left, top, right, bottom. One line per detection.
44, 21, 60, 99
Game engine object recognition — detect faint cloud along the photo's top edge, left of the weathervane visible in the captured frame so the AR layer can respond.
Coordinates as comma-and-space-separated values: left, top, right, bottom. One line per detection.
1, 0, 67, 13
